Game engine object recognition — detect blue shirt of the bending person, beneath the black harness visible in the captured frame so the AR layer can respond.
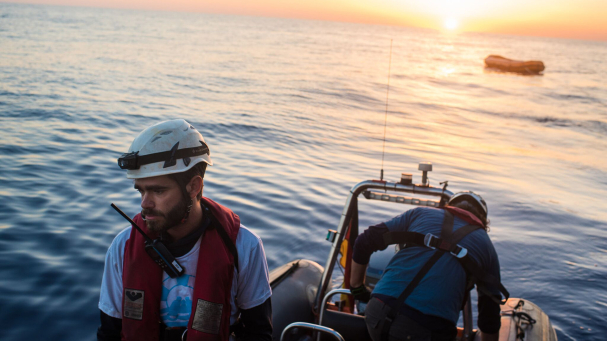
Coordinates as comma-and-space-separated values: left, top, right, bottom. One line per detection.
373, 207, 499, 323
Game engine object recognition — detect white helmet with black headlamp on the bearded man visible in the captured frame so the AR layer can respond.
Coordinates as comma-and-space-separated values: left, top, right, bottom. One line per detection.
118, 120, 213, 179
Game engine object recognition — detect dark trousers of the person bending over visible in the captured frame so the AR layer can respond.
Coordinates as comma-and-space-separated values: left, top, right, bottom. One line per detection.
365, 298, 455, 341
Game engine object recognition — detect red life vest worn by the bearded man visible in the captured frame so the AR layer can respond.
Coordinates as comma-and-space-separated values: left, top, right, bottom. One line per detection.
121, 197, 240, 341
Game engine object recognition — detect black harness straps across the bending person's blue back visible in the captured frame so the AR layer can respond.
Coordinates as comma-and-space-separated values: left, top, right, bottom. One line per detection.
381, 210, 510, 341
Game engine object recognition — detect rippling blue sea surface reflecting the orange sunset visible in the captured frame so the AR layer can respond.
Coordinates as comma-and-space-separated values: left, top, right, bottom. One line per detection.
0, 4, 607, 340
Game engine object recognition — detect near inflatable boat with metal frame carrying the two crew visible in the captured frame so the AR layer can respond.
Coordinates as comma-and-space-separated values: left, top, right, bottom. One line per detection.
270, 163, 557, 341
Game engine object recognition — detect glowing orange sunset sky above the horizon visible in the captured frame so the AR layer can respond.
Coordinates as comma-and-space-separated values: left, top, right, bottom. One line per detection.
5, 0, 607, 41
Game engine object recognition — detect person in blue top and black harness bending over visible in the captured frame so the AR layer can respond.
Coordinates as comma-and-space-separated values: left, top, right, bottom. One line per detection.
350, 191, 509, 341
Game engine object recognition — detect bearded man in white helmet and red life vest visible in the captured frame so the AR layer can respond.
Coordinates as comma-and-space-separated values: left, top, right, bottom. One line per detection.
97, 120, 272, 341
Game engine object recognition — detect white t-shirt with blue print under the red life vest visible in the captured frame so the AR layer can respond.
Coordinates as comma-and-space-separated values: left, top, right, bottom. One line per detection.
99, 225, 272, 327
